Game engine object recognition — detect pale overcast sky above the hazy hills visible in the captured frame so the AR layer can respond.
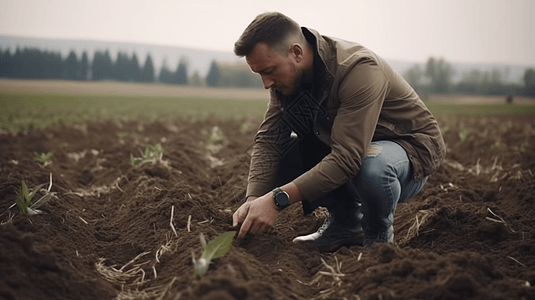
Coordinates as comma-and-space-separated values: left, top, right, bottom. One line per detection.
0, 0, 535, 65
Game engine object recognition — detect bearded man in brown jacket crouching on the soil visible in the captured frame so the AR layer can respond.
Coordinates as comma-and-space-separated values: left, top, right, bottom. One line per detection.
233, 12, 445, 251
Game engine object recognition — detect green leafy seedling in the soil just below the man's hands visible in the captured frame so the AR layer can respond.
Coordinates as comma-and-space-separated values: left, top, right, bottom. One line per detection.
191, 231, 236, 277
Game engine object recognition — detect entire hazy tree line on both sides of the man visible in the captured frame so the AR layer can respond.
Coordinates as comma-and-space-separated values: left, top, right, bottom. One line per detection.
0, 48, 535, 98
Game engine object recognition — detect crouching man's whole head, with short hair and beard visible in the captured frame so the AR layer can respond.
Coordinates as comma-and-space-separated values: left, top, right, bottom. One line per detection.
234, 12, 313, 96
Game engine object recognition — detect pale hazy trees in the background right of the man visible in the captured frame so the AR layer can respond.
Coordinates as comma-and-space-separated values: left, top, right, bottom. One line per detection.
403, 57, 535, 97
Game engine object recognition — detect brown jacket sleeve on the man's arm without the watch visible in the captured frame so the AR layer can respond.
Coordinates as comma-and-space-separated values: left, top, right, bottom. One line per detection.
246, 91, 291, 198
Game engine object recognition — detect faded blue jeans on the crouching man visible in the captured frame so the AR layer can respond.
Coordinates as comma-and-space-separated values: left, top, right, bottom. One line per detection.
276, 137, 427, 239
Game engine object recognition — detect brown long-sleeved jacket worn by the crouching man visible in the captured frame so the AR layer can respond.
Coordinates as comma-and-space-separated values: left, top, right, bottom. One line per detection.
247, 28, 446, 200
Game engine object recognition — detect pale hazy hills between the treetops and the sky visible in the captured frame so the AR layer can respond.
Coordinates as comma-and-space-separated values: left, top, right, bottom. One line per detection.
0, 35, 535, 83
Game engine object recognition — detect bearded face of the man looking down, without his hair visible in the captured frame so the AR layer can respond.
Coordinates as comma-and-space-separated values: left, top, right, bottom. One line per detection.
245, 44, 303, 96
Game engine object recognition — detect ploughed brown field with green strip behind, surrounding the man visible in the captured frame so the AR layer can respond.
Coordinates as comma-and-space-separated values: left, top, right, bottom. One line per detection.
0, 79, 535, 300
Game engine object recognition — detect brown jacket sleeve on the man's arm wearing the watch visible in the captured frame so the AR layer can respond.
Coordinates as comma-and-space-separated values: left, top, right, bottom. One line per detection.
294, 59, 390, 200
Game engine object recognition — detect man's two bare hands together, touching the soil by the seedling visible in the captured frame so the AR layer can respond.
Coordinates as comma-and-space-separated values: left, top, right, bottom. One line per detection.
232, 192, 279, 238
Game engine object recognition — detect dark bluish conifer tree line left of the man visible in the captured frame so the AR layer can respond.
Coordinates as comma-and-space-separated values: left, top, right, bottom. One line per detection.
0, 48, 261, 87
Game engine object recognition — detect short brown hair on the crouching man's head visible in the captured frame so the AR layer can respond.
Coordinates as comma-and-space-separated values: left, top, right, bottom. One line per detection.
234, 12, 301, 57
